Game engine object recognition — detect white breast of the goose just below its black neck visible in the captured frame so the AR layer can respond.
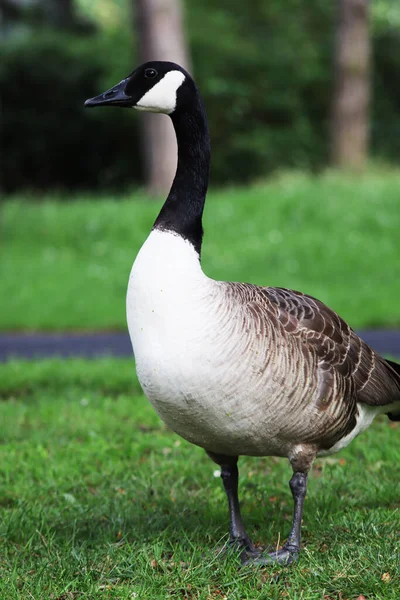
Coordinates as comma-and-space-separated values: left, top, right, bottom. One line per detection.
127, 230, 217, 410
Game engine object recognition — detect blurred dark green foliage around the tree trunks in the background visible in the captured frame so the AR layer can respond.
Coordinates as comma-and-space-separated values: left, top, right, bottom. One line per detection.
0, 0, 400, 192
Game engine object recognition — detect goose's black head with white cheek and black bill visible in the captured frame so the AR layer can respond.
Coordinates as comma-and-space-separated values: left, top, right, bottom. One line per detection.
85, 61, 191, 115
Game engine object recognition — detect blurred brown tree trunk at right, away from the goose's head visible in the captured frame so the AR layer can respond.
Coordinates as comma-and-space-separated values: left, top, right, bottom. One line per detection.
332, 0, 370, 170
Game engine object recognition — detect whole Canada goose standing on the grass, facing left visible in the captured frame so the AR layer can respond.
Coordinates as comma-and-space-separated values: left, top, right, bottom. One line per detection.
85, 61, 400, 564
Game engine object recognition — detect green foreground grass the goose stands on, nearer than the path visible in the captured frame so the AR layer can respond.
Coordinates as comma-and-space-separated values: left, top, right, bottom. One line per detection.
0, 359, 400, 600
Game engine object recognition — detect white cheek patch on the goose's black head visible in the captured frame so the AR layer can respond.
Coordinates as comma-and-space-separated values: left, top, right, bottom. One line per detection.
133, 71, 185, 115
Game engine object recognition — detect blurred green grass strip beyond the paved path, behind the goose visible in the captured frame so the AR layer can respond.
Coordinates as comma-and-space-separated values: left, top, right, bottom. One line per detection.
0, 171, 400, 330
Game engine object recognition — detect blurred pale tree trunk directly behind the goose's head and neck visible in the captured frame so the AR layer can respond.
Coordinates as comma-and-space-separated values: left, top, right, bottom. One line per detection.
135, 0, 189, 195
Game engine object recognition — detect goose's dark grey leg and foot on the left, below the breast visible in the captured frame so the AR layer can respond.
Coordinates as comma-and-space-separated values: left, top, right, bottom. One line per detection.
207, 452, 260, 562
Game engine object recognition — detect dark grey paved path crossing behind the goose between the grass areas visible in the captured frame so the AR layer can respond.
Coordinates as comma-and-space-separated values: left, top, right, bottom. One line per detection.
0, 331, 400, 361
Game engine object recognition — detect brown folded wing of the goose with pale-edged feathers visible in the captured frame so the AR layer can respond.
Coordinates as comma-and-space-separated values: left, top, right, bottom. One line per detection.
251, 286, 400, 406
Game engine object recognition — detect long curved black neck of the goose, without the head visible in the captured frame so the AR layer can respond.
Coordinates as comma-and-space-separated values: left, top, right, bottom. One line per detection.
154, 91, 210, 255
